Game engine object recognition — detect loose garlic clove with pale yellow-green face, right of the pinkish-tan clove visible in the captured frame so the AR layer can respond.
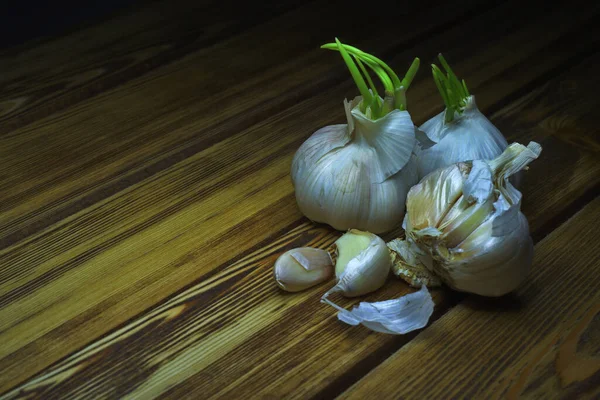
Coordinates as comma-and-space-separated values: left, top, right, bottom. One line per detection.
323, 229, 392, 297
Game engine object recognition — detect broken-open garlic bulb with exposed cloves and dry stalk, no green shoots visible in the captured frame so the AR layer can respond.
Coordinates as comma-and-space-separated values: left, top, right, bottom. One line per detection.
390, 142, 542, 296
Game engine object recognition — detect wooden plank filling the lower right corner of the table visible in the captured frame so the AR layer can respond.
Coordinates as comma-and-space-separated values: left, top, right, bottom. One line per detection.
340, 198, 600, 399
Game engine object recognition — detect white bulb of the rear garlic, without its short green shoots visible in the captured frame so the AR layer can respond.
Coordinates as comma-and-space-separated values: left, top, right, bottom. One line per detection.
418, 95, 508, 178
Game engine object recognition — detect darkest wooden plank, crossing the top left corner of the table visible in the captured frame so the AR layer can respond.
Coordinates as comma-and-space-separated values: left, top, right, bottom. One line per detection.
0, 0, 302, 135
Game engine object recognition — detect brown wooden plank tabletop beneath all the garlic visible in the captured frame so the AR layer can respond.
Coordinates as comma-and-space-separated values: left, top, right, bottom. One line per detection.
0, 0, 600, 399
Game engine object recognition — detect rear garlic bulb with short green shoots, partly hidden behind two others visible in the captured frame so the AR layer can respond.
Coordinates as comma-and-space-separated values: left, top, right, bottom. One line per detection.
418, 54, 508, 178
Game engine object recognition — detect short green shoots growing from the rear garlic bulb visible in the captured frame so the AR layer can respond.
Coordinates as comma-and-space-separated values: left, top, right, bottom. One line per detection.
431, 54, 470, 123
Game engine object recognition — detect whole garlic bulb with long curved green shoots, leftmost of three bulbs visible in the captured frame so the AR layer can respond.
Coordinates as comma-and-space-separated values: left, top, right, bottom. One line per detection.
291, 38, 419, 233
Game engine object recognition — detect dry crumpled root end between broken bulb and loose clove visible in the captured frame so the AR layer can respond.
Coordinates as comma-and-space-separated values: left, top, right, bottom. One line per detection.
387, 239, 442, 288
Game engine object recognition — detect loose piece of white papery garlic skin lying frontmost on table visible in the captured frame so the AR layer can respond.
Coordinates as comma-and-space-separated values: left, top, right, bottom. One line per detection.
322, 285, 434, 335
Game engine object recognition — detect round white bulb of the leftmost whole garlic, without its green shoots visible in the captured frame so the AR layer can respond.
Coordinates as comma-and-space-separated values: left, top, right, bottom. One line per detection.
291, 98, 418, 233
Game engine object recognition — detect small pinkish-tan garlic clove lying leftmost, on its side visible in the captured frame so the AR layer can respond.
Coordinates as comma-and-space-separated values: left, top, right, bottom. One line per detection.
273, 247, 333, 292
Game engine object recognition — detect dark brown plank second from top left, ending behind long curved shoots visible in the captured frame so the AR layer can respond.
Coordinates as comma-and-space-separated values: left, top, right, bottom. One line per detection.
0, 2, 486, 247
